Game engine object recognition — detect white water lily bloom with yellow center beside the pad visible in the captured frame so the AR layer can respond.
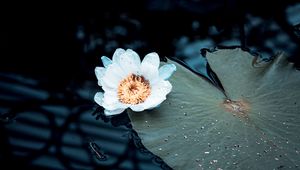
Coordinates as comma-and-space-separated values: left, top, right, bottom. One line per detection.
94, 48, 176, 115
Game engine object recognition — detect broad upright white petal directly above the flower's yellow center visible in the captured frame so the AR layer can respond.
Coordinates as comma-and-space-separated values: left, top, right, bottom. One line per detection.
119, 49, 141, 75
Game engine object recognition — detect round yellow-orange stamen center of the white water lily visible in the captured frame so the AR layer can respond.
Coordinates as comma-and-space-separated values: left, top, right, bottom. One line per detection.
118, 74, 151, 104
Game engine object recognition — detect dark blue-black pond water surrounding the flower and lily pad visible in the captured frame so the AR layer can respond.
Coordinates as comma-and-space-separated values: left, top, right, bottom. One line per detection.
0, 0, 300, 169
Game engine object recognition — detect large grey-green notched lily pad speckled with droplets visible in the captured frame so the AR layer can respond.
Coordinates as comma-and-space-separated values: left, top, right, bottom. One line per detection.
129, 48, 300, 170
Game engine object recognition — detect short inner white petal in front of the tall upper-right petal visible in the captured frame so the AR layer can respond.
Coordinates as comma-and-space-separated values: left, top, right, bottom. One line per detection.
141, 65, 159, 85
